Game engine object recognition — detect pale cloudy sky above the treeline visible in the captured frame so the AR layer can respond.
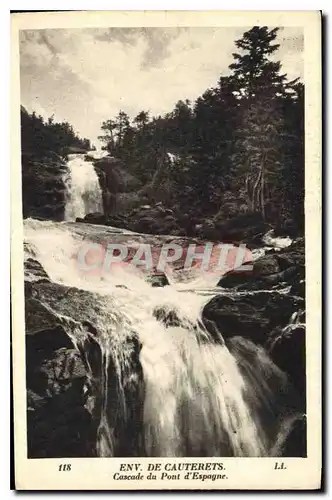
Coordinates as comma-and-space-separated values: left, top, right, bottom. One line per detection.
20, 27, 303, 146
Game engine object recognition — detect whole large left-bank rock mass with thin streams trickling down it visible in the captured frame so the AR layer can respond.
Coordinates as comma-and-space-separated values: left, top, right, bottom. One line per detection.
25, 274, 143, 458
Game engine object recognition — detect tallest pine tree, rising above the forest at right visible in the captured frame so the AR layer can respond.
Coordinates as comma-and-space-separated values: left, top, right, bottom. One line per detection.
230, 26, 294, 219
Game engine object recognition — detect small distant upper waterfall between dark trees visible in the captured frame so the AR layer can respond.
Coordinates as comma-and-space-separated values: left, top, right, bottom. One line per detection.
65, 154, 103, 221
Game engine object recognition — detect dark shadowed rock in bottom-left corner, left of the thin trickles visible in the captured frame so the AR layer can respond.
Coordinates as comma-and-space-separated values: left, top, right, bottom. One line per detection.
25, 282, 95, 458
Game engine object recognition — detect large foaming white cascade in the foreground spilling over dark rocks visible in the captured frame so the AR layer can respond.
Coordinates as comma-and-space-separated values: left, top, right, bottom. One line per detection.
25, 219, 292, 457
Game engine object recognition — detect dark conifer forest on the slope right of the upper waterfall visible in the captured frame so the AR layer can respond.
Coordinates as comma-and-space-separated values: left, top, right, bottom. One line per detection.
99, 26, 304, 234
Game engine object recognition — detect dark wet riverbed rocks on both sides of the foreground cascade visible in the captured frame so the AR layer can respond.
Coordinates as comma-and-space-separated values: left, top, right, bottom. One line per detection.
25, 222, 306, 457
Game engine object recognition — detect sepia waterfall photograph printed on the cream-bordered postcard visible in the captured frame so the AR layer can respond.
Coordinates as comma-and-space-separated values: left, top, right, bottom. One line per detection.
13, 11, 320, 489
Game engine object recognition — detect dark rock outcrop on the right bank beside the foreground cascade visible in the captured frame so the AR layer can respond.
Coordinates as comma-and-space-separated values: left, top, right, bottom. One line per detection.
202, 238, 306, 412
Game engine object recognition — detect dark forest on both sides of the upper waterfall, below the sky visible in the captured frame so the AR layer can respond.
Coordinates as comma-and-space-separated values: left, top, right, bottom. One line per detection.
21, 26, 304, 236
